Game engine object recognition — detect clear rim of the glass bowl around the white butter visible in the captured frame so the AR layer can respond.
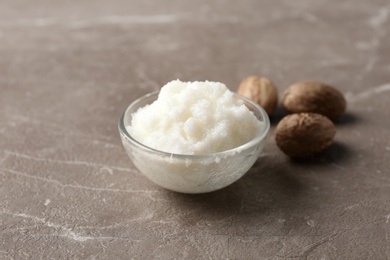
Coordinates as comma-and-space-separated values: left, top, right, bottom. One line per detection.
118, 90, 271, 160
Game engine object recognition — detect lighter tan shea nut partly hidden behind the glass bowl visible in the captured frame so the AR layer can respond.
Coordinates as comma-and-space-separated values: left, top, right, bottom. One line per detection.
237, 76, 278, 116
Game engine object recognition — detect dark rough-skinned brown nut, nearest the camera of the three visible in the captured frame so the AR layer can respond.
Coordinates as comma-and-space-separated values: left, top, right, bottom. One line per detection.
275, 113, 336, 157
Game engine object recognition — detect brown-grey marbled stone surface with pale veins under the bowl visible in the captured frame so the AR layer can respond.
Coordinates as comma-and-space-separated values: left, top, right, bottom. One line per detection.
0, 0, 390, 259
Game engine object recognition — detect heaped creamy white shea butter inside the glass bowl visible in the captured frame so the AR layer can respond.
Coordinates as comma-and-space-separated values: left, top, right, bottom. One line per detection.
127, 80, 262, 154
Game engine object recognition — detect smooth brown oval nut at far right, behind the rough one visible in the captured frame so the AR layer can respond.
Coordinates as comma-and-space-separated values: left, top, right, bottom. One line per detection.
282, 81, 347, 119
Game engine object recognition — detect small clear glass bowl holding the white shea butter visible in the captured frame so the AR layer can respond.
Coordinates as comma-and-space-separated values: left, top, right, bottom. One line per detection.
119, 92, 270, 193
